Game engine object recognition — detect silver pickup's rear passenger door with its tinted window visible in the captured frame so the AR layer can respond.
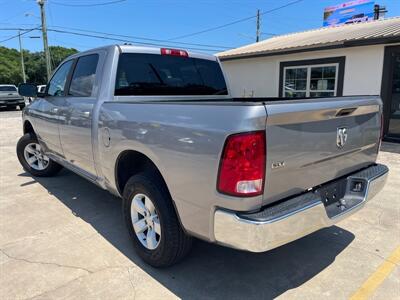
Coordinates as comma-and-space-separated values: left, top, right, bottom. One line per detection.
60, 53, 100, 177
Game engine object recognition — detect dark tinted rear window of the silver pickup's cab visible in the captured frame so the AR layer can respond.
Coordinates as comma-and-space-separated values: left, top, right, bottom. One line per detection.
115, 53, 228, 96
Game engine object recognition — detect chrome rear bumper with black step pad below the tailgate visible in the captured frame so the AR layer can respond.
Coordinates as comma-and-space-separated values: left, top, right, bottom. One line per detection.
214, 165, 389, 252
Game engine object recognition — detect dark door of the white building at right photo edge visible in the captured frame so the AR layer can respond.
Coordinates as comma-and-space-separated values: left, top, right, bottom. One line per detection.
381, 46, 400, 142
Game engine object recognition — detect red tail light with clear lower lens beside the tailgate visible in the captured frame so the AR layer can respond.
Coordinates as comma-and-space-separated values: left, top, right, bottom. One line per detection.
217, 131, 266, 196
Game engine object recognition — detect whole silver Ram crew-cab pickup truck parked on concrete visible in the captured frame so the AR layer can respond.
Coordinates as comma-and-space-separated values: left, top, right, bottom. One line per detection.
17, 45, 388, 267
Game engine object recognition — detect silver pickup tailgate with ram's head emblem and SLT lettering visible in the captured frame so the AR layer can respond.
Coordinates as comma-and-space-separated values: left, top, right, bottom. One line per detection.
263, 96, 382, 205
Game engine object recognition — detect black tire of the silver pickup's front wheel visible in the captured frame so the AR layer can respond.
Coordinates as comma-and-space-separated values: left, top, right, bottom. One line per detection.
17, 133, 62, 177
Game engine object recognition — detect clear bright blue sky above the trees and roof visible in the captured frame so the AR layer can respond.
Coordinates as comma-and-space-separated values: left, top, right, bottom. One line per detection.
0, 0, 400, 53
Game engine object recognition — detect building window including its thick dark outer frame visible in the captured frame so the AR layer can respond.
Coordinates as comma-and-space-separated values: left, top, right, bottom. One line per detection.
280, 57, 345, 98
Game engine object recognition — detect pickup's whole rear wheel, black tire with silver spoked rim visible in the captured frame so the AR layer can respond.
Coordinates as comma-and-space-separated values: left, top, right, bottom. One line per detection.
123, 173, 192, 267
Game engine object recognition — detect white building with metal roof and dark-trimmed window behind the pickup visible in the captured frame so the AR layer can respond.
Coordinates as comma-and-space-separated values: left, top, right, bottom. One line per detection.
218, 18, 400, 140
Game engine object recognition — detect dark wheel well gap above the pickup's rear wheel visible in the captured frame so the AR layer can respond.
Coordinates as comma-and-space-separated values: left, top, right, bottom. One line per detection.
115, 150, 168, 195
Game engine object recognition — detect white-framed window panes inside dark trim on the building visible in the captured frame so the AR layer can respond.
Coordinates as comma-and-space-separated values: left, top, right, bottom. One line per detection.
283, 64, 338, 98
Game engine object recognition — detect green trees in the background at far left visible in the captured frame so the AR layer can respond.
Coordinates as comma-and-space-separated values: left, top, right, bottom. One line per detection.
0, 46, 78, 85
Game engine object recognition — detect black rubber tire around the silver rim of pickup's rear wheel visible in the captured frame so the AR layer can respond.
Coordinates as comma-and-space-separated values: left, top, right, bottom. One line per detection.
122, 172, 192, 268
